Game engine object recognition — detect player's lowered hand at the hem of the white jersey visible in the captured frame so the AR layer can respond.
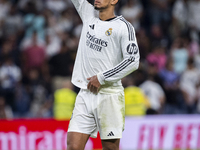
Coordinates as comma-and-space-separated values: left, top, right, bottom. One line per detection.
87, 75, 101, 94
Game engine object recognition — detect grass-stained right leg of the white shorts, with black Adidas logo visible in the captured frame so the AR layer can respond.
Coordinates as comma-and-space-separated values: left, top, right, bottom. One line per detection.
97, 92, 125, 140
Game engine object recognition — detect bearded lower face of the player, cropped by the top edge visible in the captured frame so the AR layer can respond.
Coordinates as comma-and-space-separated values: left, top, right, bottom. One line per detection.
94, 0, 112, 10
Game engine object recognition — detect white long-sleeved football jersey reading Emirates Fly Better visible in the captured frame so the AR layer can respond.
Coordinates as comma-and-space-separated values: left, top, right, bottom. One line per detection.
72, 0, 140, 89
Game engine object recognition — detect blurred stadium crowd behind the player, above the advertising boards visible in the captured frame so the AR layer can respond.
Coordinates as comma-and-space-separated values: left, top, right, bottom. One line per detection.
0, 0, 200, 119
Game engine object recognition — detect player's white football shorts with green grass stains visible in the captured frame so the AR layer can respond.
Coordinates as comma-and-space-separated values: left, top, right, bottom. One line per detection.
68, 87, 125, 139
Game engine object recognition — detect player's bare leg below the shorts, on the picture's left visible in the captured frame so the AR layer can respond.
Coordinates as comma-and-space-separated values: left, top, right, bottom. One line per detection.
67, 132, 90, 150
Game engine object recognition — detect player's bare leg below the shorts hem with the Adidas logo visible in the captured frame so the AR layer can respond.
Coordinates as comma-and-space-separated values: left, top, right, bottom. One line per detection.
101, 139, 120, 150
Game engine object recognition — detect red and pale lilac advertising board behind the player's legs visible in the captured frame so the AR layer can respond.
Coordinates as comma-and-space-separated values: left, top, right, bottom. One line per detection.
0, 115, 200, 150
